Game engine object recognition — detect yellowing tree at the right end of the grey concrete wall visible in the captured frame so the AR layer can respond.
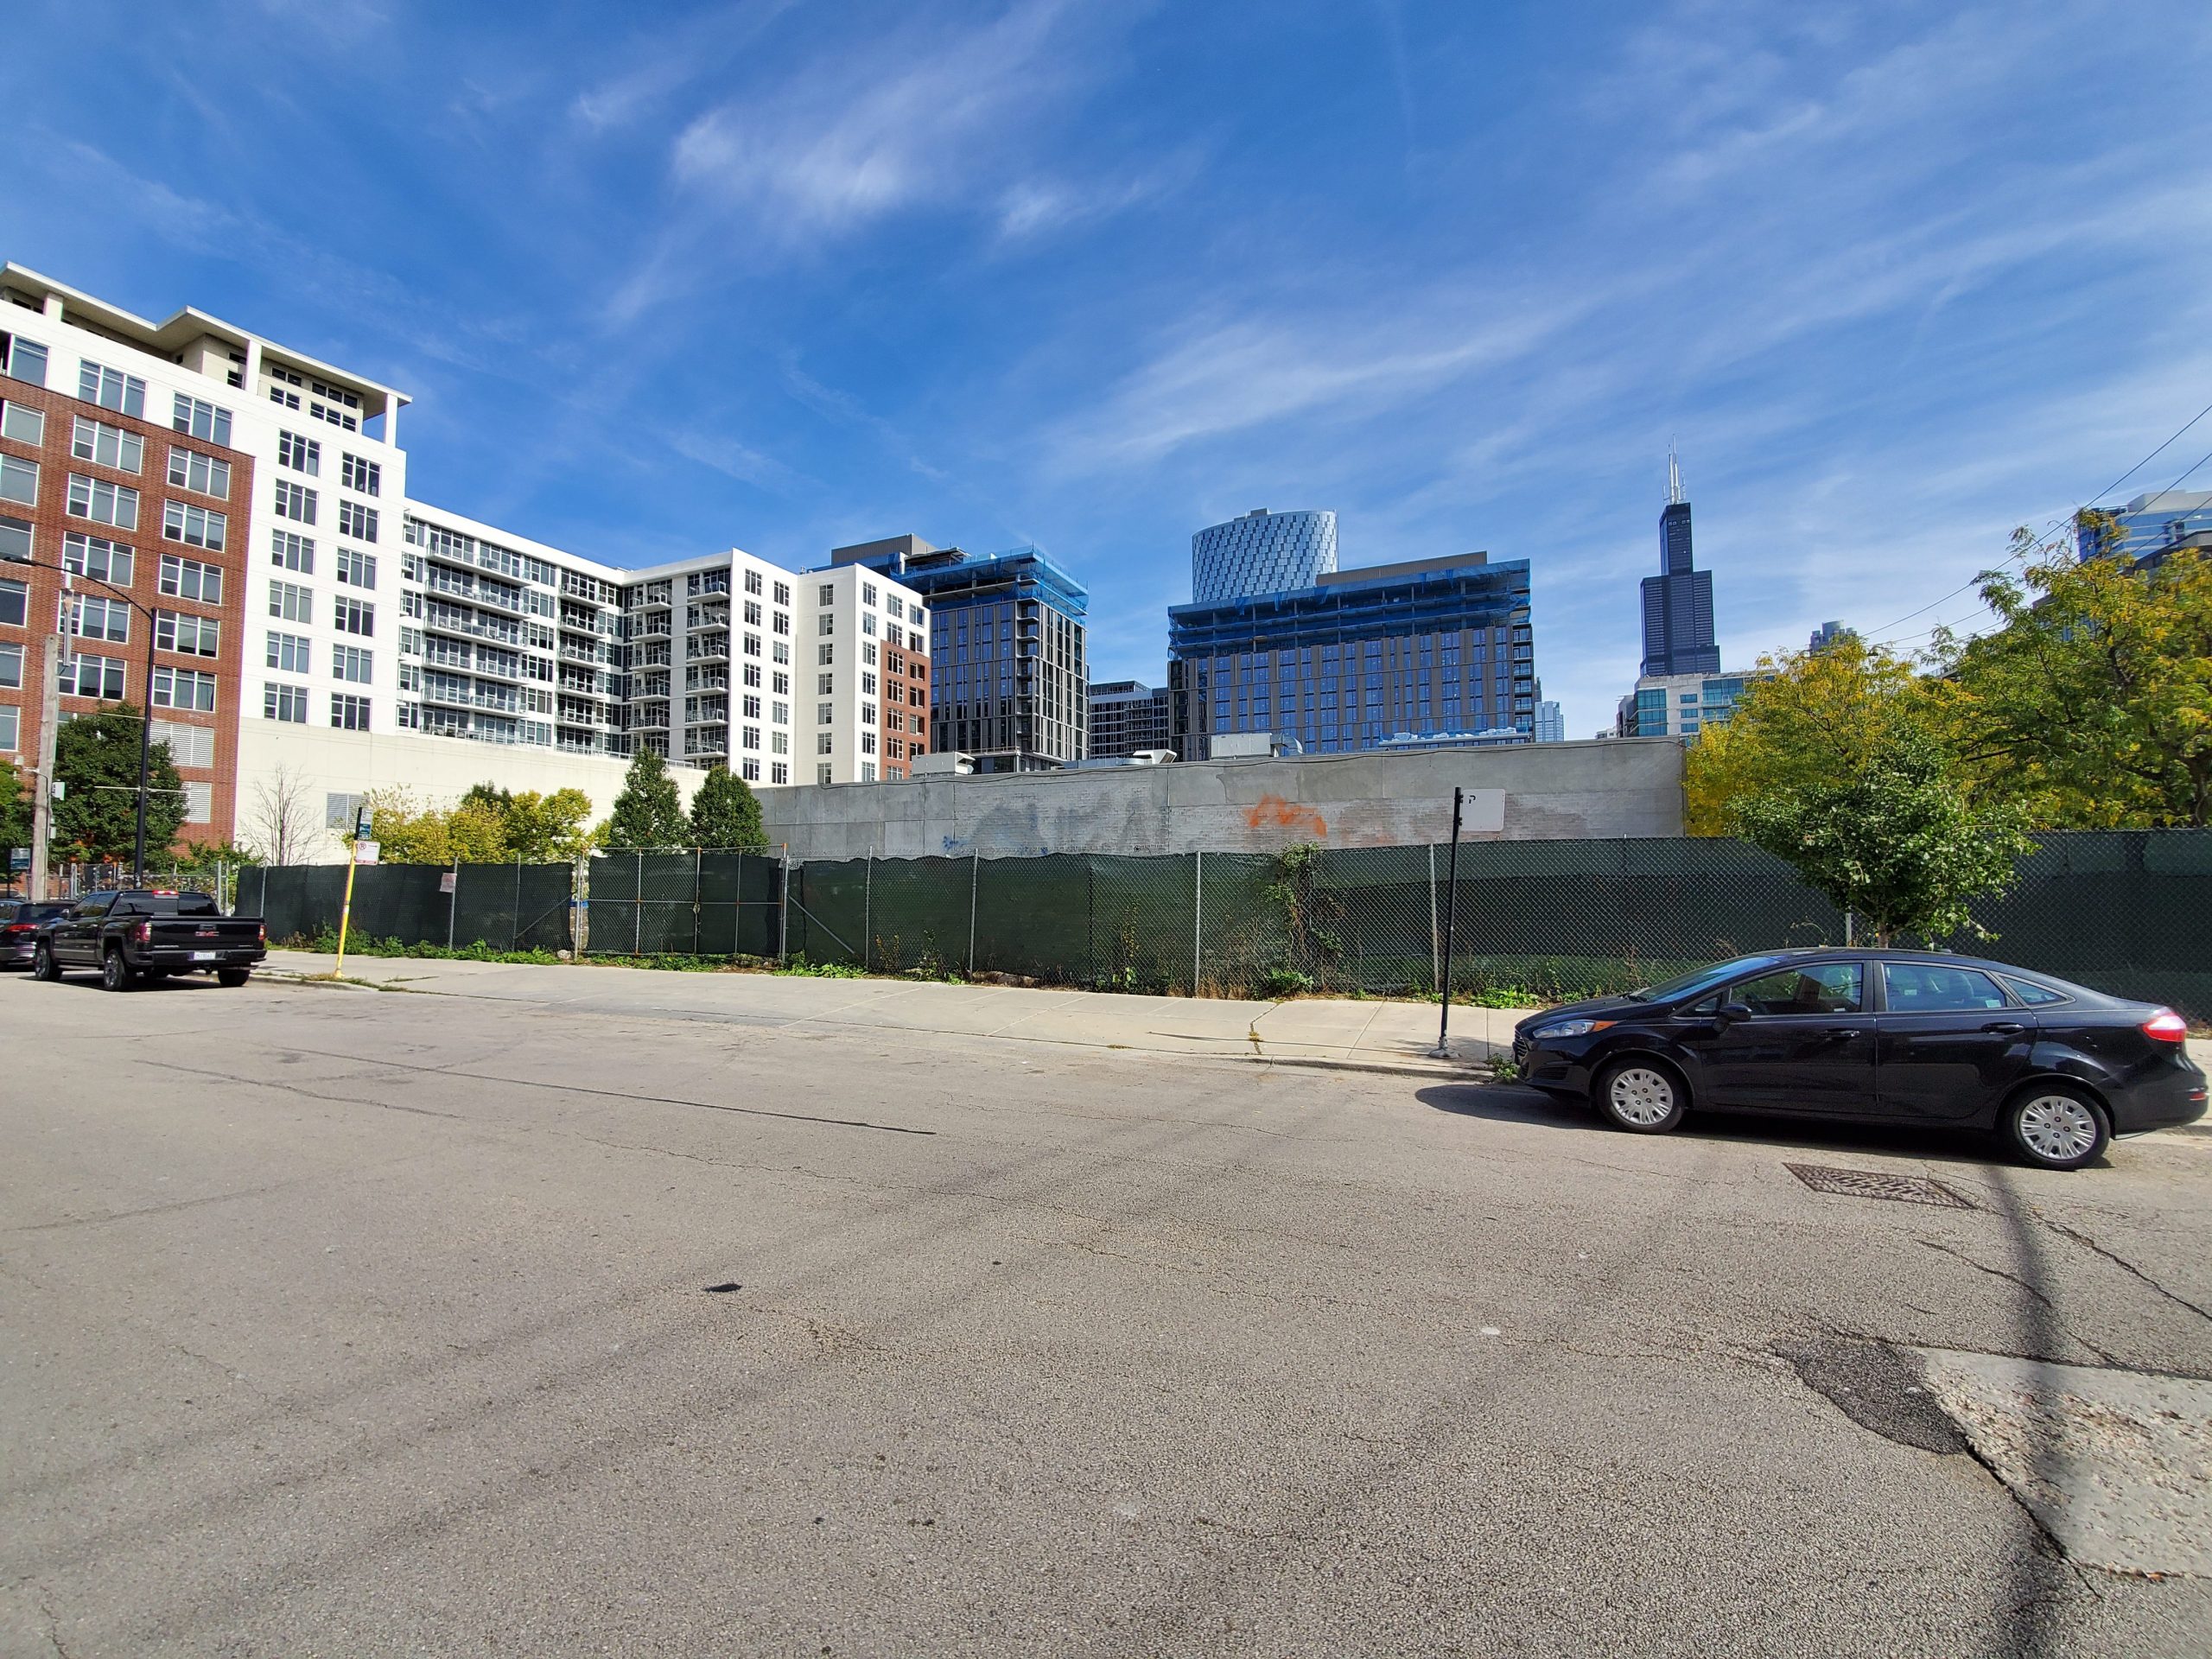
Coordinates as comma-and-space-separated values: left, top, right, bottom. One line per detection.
1683, 635, 1933, 836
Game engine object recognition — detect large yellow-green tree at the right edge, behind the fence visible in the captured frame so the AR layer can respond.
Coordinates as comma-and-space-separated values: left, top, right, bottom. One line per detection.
1933, 526, 2212, 827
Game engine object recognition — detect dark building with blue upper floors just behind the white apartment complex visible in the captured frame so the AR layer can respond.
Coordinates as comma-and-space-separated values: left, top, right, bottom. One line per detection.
830, 536, 1090, 772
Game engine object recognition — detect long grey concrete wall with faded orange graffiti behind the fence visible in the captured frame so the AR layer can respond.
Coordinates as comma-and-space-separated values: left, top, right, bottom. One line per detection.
761, 736, 1683, 858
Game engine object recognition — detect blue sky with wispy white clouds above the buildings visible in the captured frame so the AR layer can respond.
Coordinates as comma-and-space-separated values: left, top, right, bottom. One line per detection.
0, 0, 2212, 734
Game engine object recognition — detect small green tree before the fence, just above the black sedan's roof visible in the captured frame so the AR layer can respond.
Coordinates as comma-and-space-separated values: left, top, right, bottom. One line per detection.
1727, 728, 2035, 944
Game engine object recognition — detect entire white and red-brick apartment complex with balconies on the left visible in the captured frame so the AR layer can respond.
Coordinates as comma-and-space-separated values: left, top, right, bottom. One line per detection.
0, 264, 931, 871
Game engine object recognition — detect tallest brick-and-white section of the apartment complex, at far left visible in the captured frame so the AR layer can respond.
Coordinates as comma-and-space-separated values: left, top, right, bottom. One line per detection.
0, 264, 407, 841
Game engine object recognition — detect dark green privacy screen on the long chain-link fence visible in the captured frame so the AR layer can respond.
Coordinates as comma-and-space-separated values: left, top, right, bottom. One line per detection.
237, 830, 2212, 1020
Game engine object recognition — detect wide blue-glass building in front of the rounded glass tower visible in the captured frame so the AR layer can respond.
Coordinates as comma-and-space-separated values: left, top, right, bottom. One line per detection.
1168, 553, 1537, 759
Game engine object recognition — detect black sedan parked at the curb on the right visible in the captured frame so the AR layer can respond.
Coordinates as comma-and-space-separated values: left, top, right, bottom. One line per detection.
1513, 949, 2205, 1170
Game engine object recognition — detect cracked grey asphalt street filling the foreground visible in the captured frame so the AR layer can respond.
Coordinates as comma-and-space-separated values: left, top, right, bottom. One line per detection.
0, 969, 2212, 1659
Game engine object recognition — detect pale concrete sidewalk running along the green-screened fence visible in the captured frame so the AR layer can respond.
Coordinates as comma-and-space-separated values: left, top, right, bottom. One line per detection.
251, 951, 1526, 1077
